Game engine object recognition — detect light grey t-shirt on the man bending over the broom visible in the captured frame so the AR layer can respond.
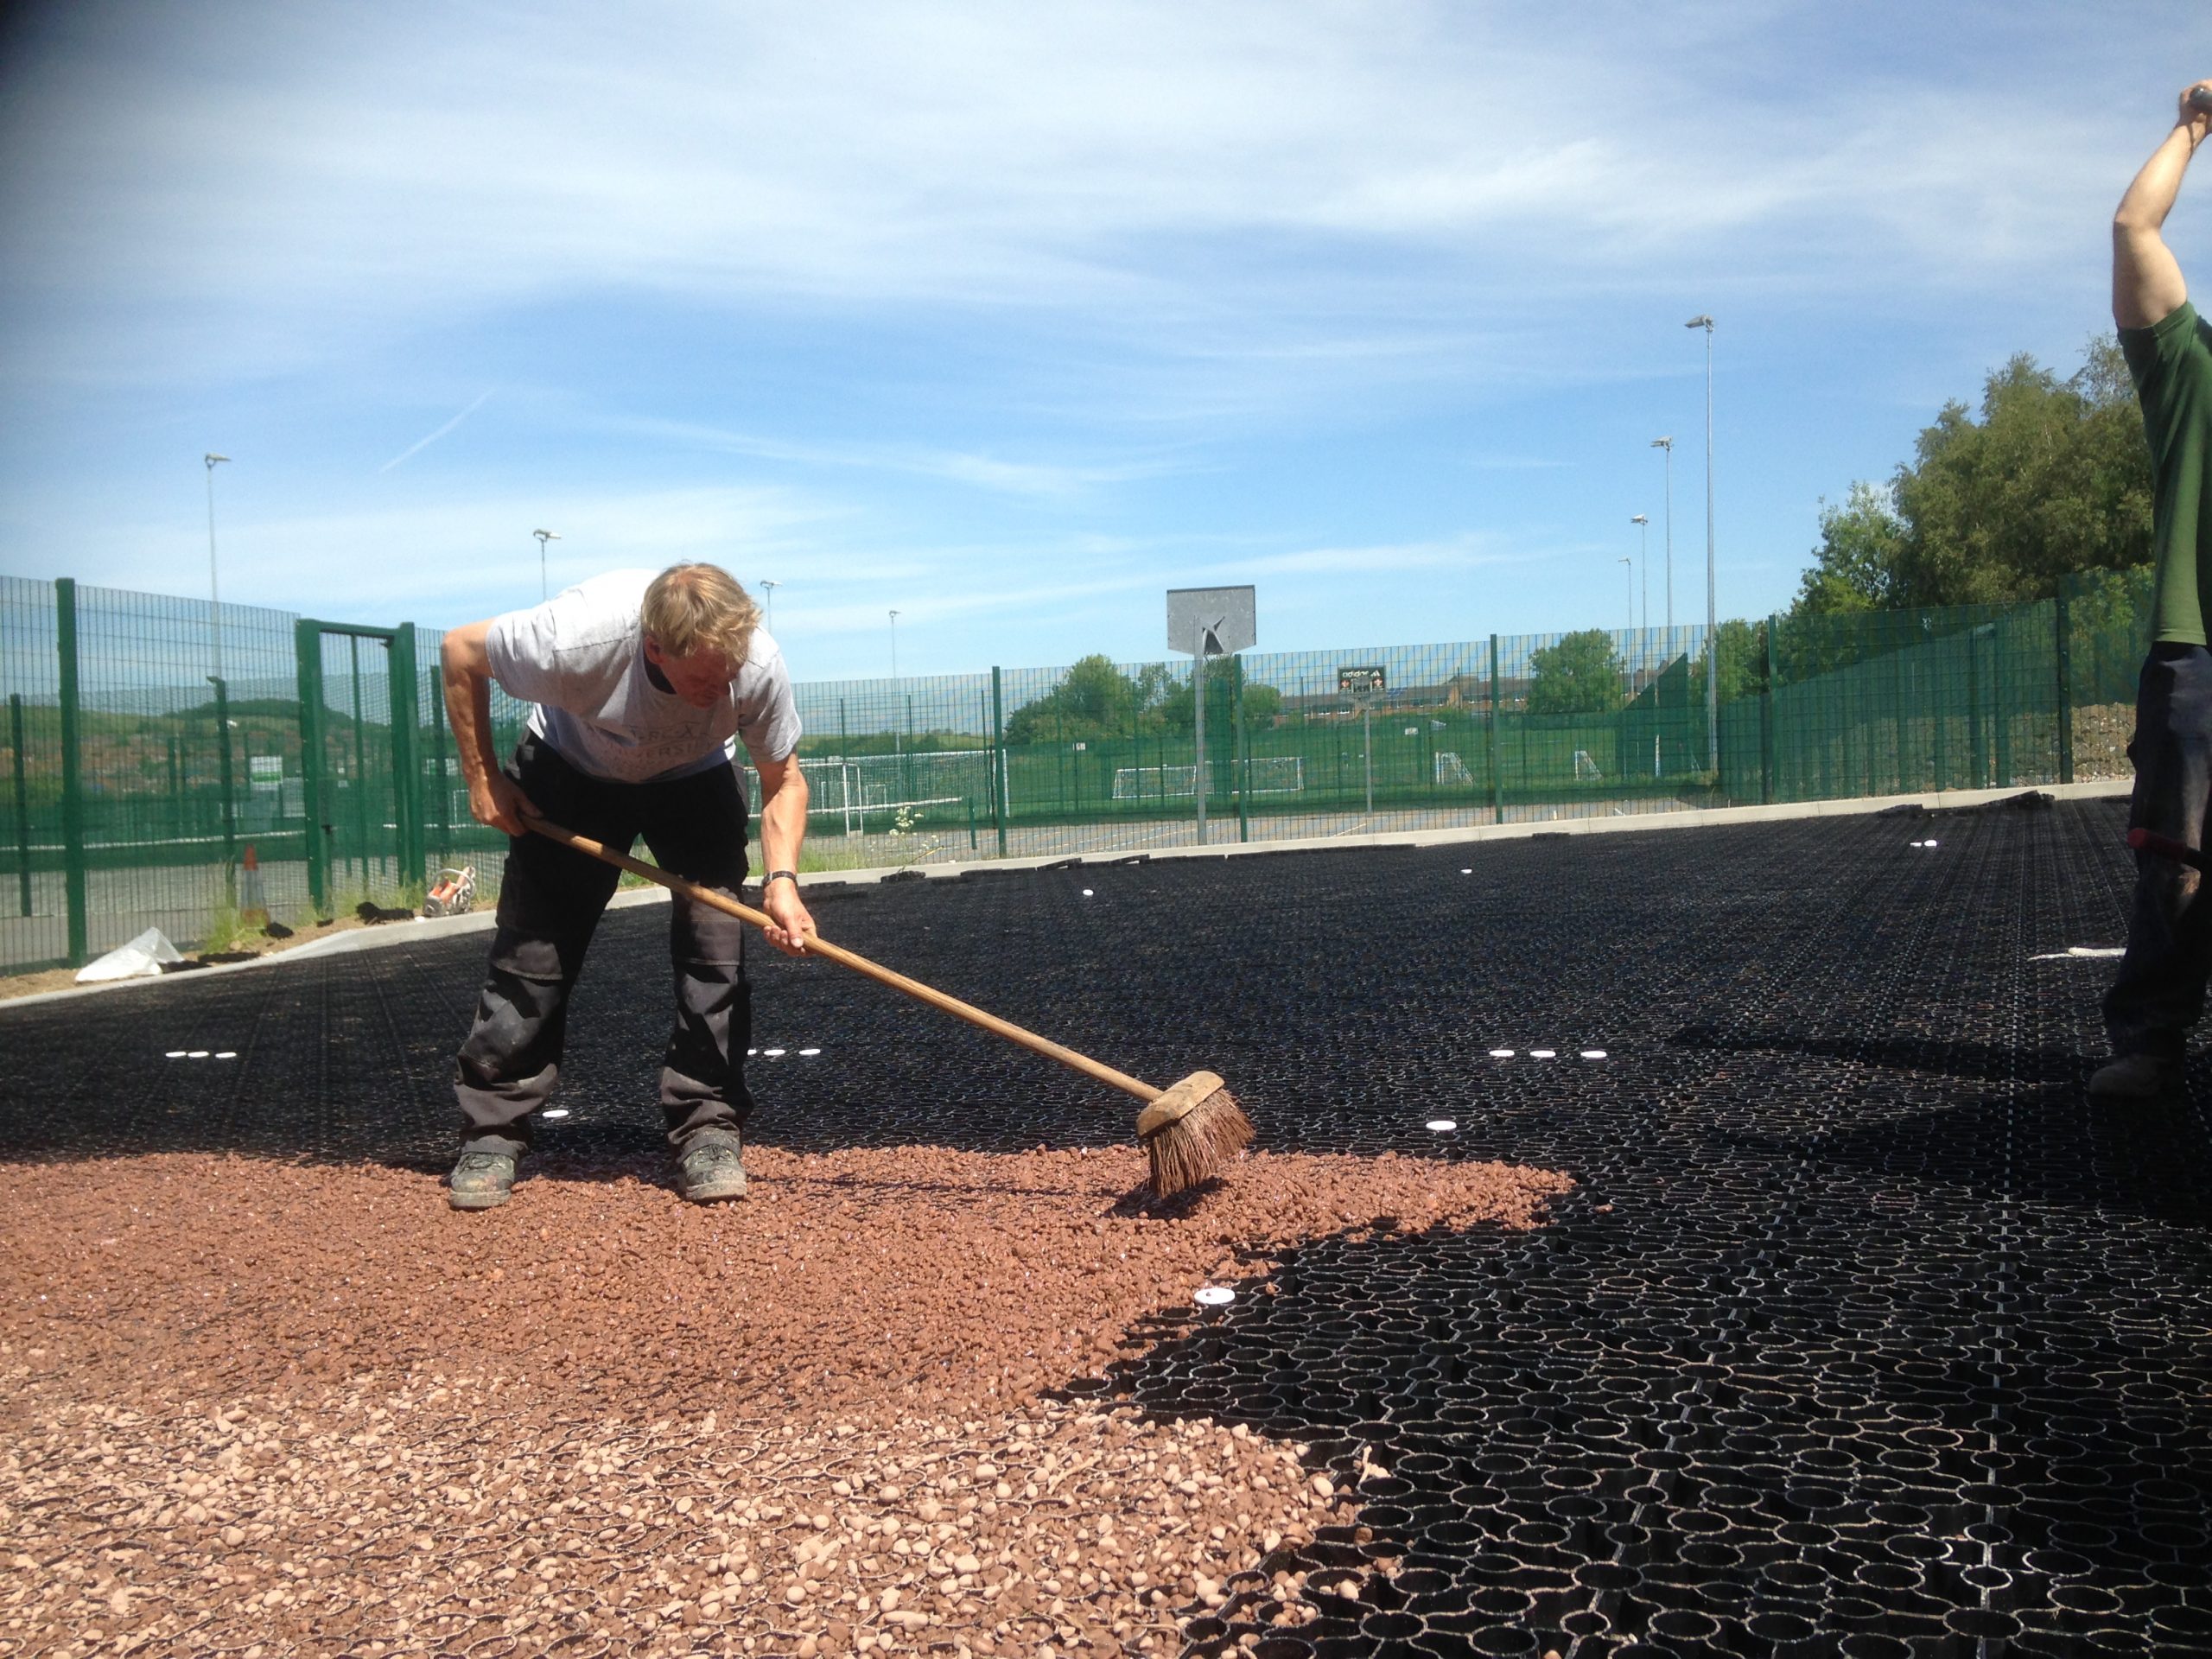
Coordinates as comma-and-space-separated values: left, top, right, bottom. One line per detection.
485, 570, 798, 783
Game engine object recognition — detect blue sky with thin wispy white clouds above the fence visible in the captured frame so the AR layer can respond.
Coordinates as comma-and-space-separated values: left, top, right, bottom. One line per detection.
0, 0, 2212, 679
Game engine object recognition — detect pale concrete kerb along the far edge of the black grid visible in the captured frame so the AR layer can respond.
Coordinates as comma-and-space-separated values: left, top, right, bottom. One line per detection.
0, 779, 2128, 1013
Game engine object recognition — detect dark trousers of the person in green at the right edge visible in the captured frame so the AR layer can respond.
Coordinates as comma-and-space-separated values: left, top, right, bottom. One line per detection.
2104, 644, 2212, 1059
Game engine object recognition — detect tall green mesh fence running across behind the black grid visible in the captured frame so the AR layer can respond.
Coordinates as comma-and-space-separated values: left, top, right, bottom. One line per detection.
0, 570, 2150, 969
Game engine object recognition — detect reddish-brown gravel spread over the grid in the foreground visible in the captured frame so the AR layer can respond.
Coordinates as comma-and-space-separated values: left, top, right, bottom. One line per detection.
0, 1148, 1568, 1659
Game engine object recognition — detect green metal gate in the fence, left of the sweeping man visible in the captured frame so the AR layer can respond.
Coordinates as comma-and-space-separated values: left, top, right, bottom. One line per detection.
296, 620, 427, 916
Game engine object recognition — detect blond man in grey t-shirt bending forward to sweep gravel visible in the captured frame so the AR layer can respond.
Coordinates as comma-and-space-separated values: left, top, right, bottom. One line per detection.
445, 564, 814, 1210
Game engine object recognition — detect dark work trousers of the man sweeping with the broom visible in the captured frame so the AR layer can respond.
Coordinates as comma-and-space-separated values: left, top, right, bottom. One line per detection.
454, 734, 752, 1154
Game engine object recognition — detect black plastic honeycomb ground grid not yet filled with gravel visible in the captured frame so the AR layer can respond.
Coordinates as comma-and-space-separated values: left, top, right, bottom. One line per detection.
0, 803, 2212, 1659
